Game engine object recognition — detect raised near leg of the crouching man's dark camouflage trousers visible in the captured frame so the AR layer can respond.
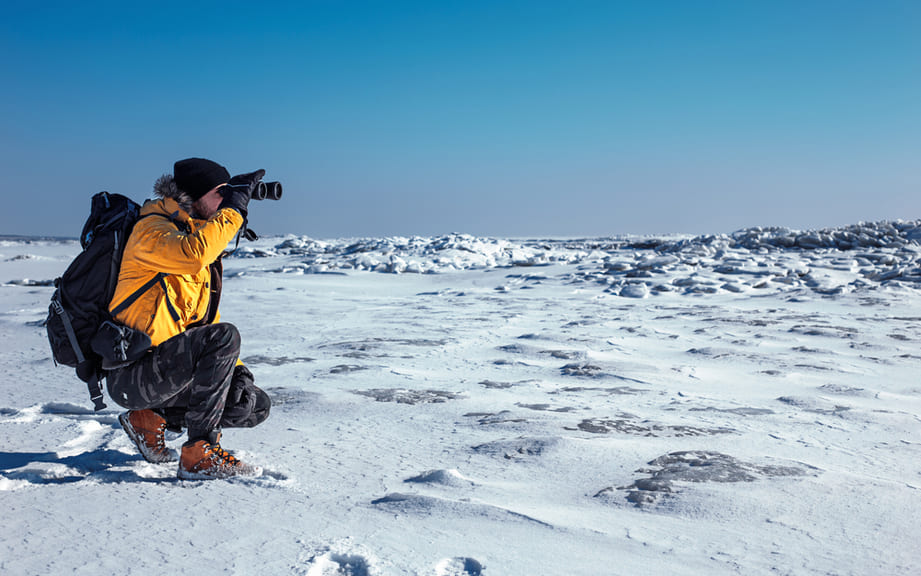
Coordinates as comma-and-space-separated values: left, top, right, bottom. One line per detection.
106, 323, 244, 439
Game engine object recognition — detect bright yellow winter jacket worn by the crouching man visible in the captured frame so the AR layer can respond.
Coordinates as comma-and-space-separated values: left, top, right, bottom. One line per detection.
109, 198, 243, 346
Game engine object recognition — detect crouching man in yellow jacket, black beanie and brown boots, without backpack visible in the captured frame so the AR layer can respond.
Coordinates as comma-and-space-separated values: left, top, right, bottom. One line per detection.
104, 158, 271, 480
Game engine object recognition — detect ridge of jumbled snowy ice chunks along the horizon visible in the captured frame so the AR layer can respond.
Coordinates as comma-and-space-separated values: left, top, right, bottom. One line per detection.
230, 220, 921, 299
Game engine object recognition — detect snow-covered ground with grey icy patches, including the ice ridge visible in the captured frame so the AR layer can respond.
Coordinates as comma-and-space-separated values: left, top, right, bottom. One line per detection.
0, 222, 921, 576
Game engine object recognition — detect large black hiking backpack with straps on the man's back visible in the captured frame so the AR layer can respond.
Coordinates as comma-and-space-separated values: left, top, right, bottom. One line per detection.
45, 192, 178, 411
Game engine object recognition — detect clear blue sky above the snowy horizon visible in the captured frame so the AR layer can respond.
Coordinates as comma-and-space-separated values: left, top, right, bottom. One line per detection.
0, 0, 921, 238
